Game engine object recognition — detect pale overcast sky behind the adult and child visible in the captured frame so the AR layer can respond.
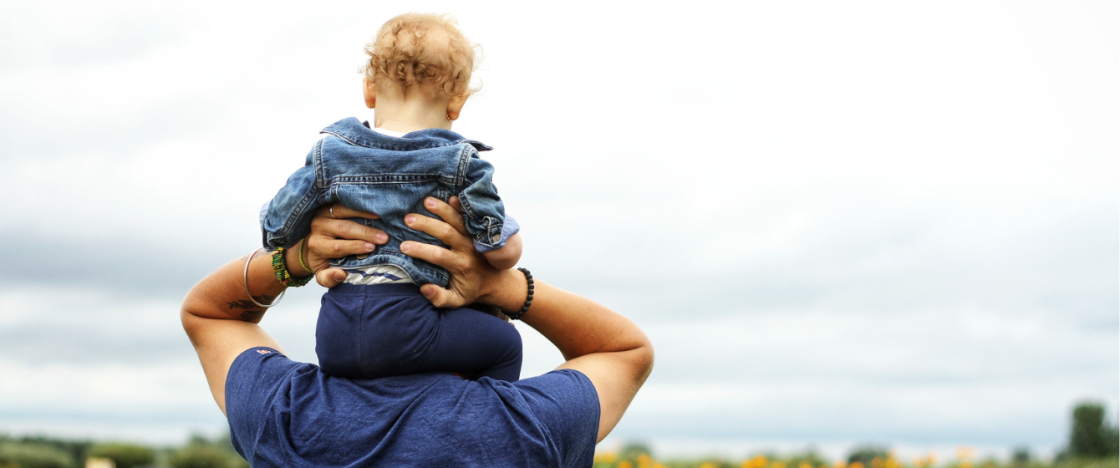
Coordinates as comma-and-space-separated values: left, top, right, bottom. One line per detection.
0, 0, 1120, 456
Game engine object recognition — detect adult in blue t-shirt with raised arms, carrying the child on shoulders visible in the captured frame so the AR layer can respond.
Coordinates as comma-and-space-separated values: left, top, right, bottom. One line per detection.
181, 198, 653, 467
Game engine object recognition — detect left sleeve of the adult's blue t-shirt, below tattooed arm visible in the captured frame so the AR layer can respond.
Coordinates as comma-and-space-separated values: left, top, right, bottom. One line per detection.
225, 347, 309, 460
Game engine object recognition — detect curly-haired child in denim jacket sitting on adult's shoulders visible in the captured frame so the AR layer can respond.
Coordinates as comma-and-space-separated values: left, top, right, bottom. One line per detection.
261, 13, 521, 382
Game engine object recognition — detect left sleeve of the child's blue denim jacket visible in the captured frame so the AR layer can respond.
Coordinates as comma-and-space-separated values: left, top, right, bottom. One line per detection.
261, 144, 323, 249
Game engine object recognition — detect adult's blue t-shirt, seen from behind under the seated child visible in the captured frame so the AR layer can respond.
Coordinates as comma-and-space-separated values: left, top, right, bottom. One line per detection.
225, 348, 599, 467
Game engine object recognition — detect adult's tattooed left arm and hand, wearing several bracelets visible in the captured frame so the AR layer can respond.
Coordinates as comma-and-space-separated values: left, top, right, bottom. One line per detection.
180, 206, 388, 413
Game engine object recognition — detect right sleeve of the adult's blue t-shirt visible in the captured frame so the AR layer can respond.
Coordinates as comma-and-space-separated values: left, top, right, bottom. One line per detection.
512, 369, 599, 467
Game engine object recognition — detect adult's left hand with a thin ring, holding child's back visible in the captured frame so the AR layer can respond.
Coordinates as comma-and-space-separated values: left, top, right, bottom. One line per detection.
306, 204, 389, 288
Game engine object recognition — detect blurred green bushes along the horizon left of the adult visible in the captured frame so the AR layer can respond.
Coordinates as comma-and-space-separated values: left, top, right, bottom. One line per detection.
0, 436, 249, 468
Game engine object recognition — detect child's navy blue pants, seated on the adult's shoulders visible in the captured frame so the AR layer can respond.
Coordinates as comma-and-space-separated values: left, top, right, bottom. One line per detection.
315, 283, 522, 382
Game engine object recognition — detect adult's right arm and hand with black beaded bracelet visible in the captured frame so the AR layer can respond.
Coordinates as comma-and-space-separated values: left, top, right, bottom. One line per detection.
401, 198, 653, 440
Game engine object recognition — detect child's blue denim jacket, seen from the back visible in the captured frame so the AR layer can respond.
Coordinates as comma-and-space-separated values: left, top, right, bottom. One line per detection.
261, 118, 520, 287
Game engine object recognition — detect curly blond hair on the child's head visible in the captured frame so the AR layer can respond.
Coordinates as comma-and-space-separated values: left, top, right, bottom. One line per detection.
362, 13, 477, 97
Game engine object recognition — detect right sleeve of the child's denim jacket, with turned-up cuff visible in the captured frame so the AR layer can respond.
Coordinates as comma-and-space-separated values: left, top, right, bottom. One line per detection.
459, 153, 520, 252
